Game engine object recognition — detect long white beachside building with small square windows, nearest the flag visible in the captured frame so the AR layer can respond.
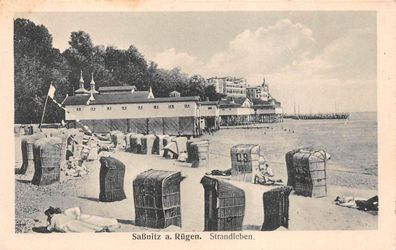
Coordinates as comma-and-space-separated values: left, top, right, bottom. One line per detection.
63, 77, 201, 136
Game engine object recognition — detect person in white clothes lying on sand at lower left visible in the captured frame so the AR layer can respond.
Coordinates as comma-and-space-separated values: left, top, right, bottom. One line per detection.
44, 207, 120, 233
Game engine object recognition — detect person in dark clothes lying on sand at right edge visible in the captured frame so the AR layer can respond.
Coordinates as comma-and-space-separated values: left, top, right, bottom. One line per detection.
334, 195, 378, 211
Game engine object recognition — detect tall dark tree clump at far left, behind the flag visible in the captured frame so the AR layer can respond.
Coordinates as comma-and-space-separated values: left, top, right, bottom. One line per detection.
14, 18, 68, 123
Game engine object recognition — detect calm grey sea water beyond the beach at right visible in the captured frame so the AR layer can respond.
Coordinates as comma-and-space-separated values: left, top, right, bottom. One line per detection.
205, 112, 378, 189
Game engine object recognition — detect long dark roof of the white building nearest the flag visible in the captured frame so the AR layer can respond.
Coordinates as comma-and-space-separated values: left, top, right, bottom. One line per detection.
64, 91, 203, 106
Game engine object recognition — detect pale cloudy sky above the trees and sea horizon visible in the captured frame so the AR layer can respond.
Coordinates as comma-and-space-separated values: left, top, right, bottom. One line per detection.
16, 11, 377, 113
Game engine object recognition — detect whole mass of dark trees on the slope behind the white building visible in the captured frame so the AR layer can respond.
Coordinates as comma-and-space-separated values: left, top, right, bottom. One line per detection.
14, 18, 222, 123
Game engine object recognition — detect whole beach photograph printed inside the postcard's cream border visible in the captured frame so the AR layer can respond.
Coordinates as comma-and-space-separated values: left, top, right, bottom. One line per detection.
3, 0, 396, 249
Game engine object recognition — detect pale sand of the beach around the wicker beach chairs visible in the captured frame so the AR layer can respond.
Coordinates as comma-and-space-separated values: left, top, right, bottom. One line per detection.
15, 125, 378, 232
